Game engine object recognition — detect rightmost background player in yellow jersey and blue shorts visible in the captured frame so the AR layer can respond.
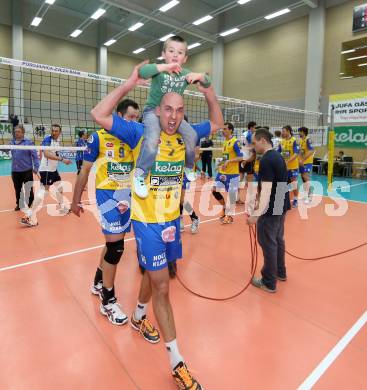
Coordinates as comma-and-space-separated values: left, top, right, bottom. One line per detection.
298, 127, 315, 204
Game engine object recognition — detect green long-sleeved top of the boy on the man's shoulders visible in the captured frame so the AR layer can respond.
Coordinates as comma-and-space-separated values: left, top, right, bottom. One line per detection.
139, 64, 210, 108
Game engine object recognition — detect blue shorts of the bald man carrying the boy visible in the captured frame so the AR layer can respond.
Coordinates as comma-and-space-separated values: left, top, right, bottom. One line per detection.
132, 218, 182, 271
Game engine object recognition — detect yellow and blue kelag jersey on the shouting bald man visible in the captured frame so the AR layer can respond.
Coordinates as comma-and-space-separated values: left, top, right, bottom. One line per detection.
110, 115, 211, 223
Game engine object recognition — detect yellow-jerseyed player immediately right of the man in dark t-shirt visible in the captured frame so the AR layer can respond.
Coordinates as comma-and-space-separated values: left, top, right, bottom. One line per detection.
278, 125, 299, 207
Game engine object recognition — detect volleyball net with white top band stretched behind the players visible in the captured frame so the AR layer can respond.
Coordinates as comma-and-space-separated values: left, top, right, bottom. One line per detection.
0, 57, 327, 155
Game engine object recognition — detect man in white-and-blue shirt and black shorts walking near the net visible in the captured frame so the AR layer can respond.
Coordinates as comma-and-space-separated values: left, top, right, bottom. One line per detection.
20, 124, 71, 227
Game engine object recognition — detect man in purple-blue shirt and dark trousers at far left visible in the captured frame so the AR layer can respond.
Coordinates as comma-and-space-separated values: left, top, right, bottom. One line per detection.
10, 125, 39, 211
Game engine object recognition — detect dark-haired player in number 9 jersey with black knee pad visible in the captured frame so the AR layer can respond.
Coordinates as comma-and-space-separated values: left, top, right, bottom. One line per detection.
71, 99, 147, 330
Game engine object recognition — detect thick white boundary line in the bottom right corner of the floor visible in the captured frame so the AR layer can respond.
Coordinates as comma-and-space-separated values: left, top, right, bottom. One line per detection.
297, 311, 367, 390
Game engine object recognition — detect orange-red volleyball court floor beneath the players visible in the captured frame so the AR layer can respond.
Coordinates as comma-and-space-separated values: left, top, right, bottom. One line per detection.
0, 173, 367, 390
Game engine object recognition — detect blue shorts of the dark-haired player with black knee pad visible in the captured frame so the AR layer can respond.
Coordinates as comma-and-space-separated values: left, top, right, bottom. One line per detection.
96, 189, 131, 234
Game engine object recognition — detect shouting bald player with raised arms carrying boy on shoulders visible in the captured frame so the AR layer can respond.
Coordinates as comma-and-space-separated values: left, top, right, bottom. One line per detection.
91, 63, 223, 390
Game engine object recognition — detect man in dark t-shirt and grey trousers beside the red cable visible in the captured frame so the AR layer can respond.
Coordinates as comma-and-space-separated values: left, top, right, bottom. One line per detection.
247, 128, 290, 293
